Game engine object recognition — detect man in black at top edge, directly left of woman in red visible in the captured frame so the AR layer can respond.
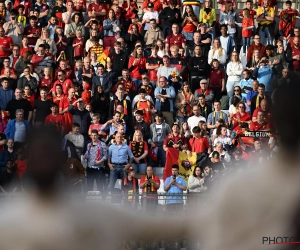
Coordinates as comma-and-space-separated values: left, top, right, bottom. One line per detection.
159, 0, 185, 39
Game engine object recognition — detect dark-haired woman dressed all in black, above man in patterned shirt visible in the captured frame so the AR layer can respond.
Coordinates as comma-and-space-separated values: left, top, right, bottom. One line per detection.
91, 85, 109, 124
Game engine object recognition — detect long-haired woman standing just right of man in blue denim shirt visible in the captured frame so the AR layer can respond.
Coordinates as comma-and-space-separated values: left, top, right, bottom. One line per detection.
175, 82, 194, 123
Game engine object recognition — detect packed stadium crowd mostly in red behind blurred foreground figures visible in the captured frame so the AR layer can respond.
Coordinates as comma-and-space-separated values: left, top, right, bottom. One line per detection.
0, 0, 300, 204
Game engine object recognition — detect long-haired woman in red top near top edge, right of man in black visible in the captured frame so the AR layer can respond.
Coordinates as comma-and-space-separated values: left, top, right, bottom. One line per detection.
181, 5, 198, 42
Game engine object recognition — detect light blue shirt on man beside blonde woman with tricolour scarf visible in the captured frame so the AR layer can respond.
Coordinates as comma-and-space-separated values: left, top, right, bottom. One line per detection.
108, 143, 134, 164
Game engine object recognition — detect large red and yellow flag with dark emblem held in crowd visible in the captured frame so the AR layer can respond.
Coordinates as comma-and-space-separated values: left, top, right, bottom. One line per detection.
164, 148, 197, 185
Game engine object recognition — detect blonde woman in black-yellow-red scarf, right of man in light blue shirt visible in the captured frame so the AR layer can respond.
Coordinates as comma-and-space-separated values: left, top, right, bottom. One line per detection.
129, 130, 148, 173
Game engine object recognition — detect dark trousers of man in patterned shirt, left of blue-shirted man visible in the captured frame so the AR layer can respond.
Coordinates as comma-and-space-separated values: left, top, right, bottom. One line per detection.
86, 167, 105, 193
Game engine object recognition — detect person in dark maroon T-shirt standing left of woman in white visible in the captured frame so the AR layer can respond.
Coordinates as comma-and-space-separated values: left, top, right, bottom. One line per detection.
208, 59, 225, 100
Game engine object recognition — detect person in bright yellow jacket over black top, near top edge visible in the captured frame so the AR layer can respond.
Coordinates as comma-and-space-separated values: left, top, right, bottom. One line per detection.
199, 0, 217, 41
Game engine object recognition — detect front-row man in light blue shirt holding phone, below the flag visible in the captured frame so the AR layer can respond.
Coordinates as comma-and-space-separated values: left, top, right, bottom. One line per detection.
164, 165, 186, 214
